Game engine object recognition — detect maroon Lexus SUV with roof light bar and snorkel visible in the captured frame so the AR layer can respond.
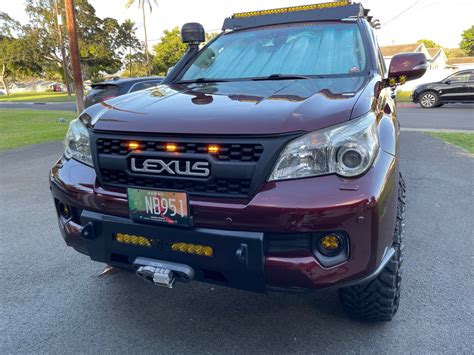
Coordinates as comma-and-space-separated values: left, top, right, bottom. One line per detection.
50, 1, 426, 320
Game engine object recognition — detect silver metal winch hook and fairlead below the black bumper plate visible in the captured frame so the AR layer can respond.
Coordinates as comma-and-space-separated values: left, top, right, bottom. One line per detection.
133, 258, 194, 288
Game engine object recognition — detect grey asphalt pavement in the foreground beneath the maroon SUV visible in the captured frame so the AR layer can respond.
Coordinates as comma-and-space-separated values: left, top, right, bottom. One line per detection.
0, 132, 474, 354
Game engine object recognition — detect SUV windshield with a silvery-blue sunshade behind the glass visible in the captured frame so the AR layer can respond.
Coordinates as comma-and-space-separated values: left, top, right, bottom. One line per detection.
181, 23, 366, 81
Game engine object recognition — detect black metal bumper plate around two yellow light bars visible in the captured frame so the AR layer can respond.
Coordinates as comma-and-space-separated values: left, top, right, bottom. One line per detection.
81, 211, 266, 292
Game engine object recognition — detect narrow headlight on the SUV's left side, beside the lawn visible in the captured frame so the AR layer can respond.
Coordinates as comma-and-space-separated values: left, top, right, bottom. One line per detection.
64, 118, 93, 166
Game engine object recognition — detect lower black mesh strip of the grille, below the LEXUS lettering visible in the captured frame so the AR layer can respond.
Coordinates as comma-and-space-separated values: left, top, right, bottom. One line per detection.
100, 169, 251, 197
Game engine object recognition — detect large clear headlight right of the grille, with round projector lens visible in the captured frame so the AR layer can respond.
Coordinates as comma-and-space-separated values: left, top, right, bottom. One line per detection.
269, 113, 379, 181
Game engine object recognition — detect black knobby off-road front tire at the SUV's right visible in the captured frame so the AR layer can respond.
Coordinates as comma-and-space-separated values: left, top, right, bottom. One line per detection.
339, 175, 406, 321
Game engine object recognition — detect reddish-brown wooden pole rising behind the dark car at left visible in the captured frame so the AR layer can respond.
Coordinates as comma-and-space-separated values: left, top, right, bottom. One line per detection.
64, 0, 84, 113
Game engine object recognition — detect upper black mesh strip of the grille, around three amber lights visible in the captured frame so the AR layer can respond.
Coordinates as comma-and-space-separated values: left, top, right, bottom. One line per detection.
97, 138, 263, 162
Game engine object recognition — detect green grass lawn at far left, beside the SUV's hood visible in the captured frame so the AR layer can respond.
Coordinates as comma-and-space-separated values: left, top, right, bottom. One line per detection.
0, 109, 76, 150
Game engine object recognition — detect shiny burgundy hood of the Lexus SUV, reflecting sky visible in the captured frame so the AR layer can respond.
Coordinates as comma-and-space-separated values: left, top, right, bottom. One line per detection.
90, 77, 367, 135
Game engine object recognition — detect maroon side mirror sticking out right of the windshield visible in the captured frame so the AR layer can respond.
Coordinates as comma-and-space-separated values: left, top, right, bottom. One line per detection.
388, 53, 428, 86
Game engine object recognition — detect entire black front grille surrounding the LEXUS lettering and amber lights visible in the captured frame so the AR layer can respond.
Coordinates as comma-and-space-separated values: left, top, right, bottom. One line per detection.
91, 132, 302, 200
